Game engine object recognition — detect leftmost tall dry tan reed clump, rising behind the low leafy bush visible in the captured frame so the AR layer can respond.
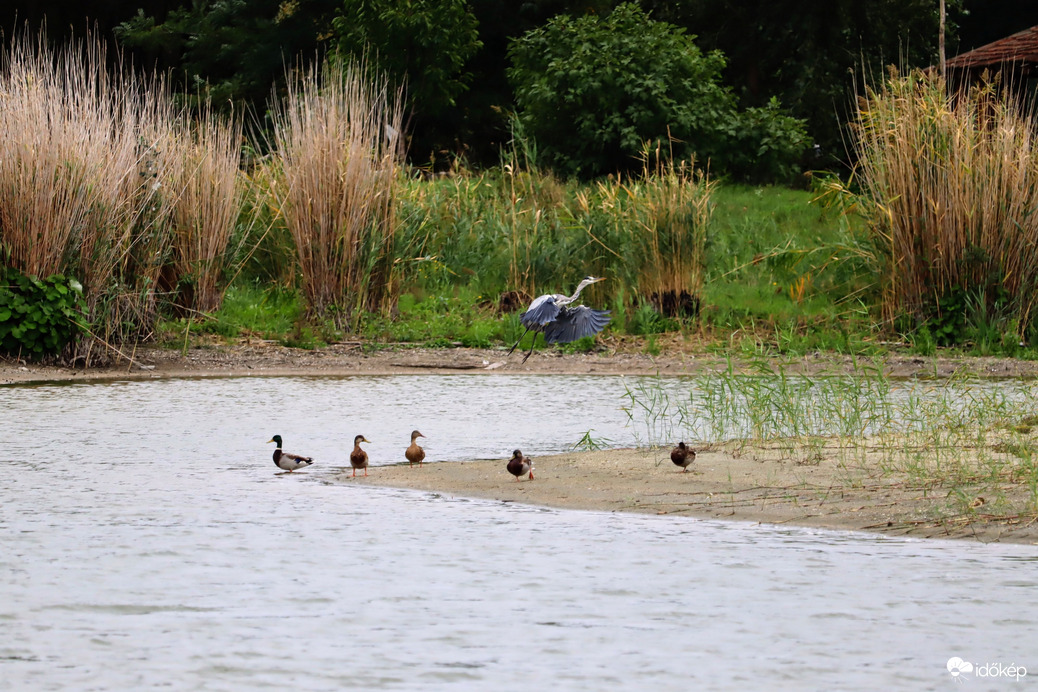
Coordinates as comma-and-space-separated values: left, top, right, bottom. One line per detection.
0, 33, 180, 360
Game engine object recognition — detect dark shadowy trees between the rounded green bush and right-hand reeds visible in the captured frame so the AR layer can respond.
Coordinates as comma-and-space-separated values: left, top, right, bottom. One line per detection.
643, 0, 959, 166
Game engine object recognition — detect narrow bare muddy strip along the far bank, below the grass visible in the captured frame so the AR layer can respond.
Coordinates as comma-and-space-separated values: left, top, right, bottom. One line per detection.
0, 339, 1038, 384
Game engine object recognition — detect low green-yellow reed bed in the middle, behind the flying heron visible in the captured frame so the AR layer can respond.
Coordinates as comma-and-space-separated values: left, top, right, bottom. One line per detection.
398, 156, 713, 327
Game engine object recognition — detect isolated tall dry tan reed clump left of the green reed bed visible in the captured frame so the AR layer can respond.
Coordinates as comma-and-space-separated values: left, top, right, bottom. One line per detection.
273, 63, 403, 330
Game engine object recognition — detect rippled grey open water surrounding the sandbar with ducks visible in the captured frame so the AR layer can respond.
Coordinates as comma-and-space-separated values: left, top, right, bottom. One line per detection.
0, 376, 1038, 690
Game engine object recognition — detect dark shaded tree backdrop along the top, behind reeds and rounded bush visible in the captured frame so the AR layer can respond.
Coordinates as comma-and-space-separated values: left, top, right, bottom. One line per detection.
10, 0, 1038, 176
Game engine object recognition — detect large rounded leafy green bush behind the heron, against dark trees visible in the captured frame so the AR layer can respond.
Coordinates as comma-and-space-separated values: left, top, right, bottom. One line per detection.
509, 4, 805, 177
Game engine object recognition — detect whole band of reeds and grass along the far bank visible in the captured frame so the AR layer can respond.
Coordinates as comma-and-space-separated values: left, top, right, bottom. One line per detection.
0, 35, 1038, 363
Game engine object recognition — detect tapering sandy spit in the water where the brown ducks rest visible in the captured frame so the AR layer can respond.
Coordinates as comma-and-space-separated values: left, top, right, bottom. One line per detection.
342, 445, 1038, 545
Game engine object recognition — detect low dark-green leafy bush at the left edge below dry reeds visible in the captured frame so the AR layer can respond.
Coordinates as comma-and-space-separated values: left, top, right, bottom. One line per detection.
0, 268, 85, 360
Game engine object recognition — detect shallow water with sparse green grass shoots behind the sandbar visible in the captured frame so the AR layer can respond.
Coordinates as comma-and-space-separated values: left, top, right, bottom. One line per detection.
624, 361, 1038, 520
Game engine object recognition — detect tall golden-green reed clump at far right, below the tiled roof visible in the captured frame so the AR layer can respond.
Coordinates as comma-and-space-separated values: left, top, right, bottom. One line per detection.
855, 73, 1038, 333
